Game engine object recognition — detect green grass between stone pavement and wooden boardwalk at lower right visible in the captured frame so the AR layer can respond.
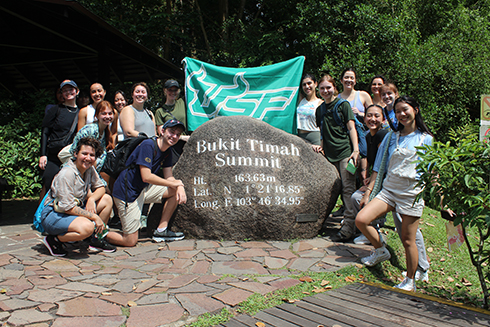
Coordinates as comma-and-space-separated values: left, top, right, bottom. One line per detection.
191, 208, 483, 327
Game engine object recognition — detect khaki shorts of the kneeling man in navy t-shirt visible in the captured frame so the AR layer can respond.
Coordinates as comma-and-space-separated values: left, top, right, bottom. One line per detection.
114, 184, 167, 234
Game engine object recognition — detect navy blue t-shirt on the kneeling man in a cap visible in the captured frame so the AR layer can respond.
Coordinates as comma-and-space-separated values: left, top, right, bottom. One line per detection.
112, 139, 172, 202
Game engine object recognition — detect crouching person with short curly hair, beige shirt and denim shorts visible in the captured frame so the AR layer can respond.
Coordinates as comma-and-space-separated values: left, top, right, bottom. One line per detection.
41, 137, 116, 256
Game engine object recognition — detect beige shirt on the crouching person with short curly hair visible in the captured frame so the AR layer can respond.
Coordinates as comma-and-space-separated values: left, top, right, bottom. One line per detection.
44, 160, 104, 211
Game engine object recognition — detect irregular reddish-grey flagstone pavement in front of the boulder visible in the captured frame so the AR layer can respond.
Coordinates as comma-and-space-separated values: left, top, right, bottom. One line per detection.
0, 224, 370, 327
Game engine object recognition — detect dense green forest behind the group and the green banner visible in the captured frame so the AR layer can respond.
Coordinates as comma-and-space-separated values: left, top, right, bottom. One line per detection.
0, 0, 490, 196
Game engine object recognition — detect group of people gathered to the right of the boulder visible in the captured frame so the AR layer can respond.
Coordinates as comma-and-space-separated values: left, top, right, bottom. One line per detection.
297, 68, 432, 291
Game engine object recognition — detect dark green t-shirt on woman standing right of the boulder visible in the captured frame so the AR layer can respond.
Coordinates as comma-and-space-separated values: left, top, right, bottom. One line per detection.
316, 98, 354, 162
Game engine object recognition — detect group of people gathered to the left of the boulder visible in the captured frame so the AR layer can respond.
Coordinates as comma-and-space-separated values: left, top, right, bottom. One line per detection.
39, 80, 188, 256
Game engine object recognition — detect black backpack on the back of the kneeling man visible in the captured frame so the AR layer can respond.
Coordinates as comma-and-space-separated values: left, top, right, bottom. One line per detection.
101, 133, 158, 179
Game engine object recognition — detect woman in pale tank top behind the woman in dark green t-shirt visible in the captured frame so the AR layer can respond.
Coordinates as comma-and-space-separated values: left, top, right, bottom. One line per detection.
339, 68, 373, 122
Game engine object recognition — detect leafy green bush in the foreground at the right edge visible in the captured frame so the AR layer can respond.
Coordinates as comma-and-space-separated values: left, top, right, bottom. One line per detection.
417, 124, 490, 308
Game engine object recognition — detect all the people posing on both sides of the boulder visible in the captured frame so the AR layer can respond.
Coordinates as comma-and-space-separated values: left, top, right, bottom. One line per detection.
39, 68, 432, 290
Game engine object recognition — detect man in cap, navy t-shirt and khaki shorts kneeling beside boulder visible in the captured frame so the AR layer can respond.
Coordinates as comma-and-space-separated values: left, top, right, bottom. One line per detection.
108, 119, 187, 246
